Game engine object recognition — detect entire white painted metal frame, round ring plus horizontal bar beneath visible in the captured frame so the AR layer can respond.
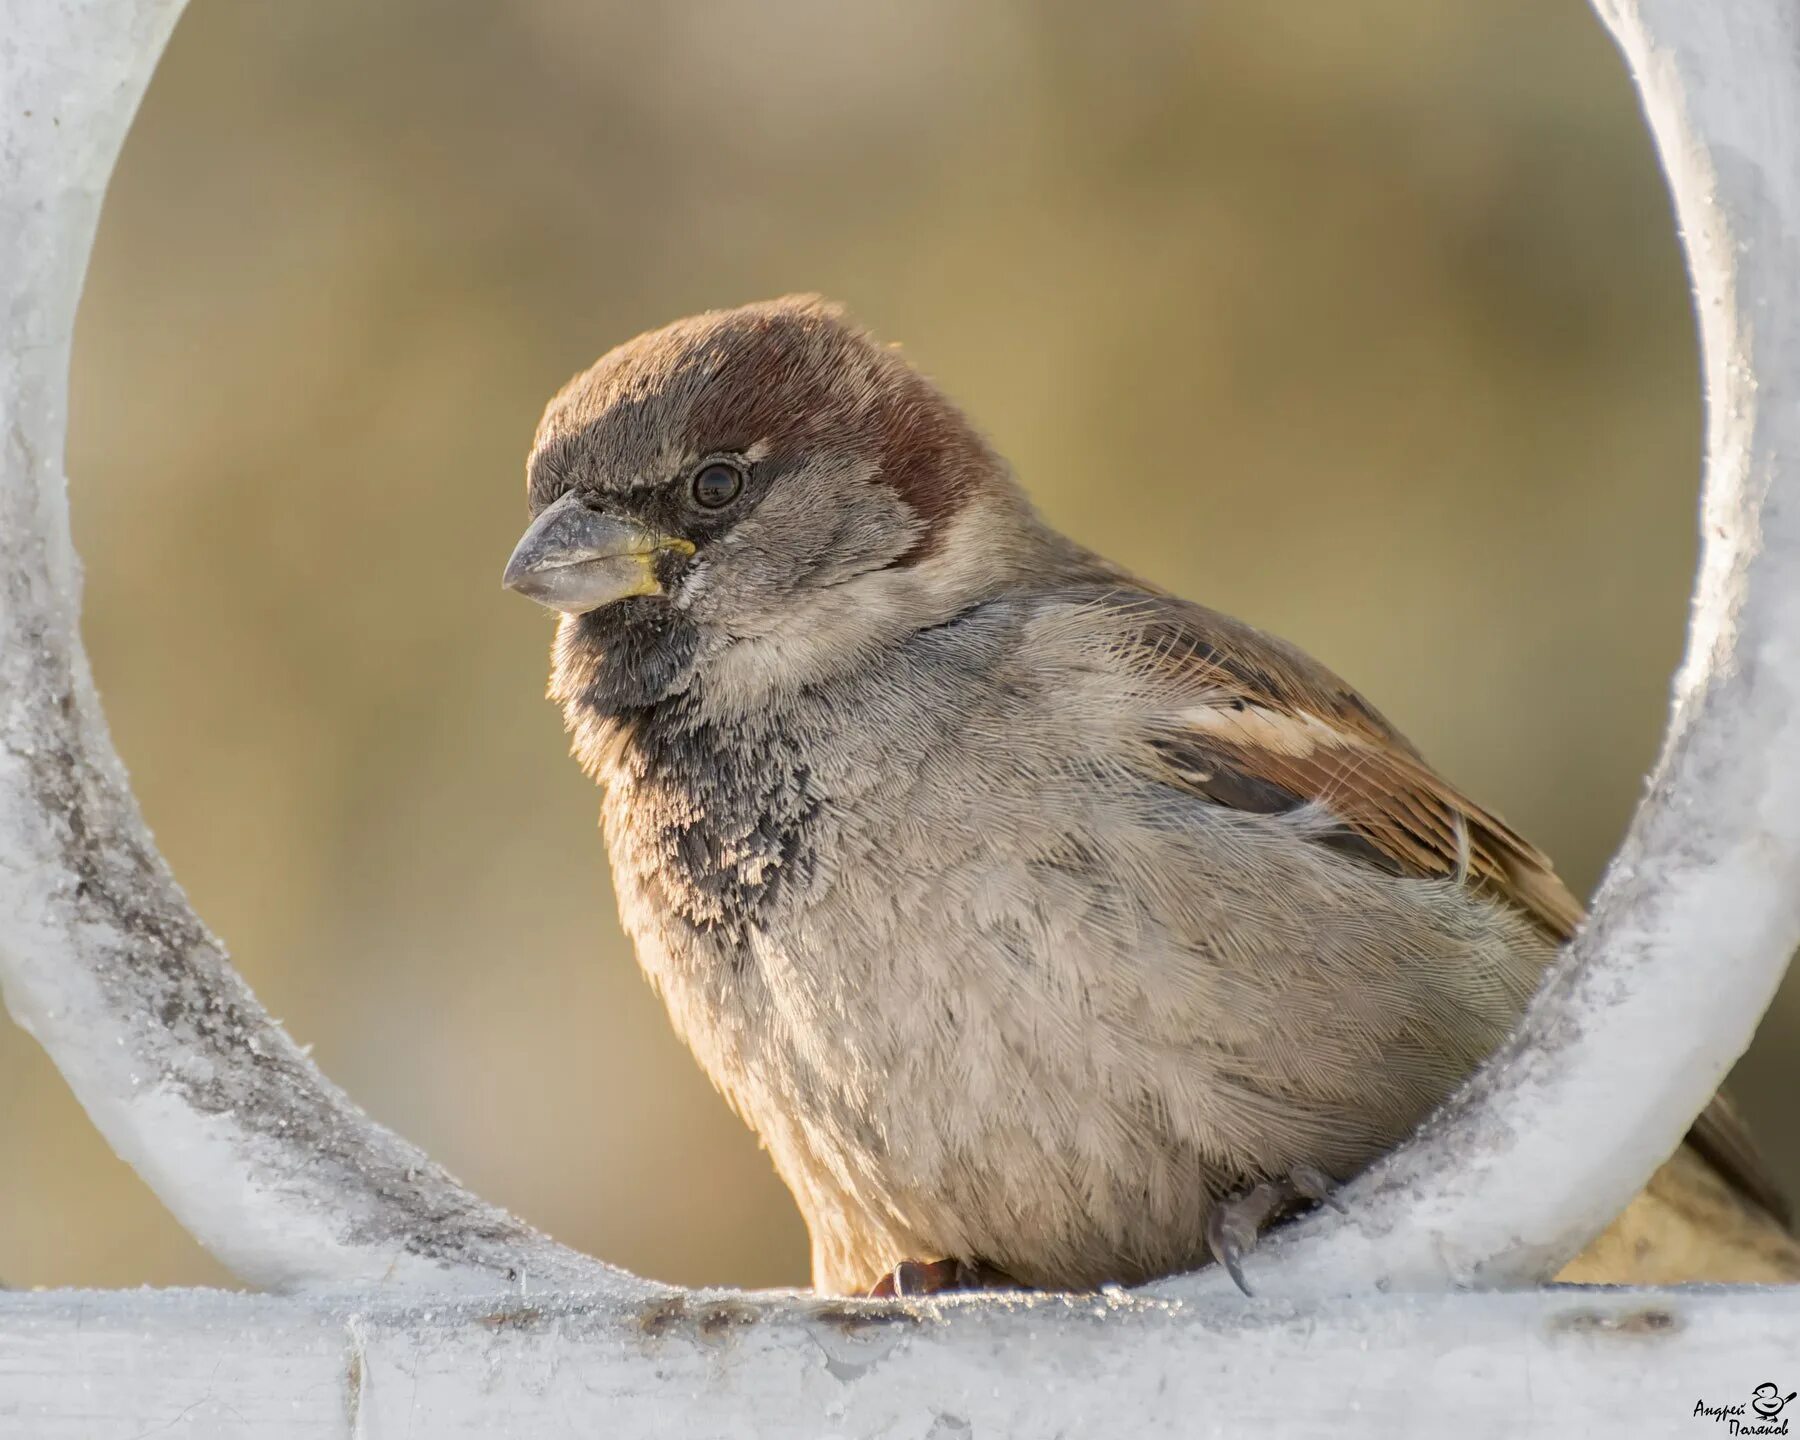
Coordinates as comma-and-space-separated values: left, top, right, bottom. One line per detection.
0, 0, 1800, 1440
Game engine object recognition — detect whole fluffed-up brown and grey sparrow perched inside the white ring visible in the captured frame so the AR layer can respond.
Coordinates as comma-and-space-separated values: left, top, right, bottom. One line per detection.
504, 297, 1800, 1294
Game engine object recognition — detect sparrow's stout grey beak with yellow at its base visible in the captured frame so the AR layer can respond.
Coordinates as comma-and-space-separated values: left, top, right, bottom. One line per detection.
500, 495, 693, 616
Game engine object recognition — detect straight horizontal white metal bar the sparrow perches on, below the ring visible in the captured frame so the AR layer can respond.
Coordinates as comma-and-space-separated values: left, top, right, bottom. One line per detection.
0, 1289, 1800, 1440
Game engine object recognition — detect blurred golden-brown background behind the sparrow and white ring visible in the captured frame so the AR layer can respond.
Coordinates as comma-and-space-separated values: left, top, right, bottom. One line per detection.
0, 0, 1800, 1285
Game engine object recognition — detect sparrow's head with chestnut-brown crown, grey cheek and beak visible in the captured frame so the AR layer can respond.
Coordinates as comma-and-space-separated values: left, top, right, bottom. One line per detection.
504, 297, 1044, 720
